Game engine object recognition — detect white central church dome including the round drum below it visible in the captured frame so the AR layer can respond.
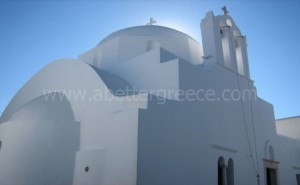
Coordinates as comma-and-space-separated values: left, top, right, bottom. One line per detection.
90, 25, 202, 67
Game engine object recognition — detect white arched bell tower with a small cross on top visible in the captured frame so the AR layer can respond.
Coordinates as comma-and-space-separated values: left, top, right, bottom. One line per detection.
200, 7, 250, 78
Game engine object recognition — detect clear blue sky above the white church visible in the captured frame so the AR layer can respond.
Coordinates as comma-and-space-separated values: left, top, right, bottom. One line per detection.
0, 0, 300, 118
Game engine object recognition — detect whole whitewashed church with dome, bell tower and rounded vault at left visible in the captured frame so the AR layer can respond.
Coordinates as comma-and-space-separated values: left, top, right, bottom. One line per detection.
0, 8, 300, 185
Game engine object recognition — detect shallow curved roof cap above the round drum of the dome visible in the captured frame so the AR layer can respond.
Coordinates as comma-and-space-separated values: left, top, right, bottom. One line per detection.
97, 25, 198, 46
